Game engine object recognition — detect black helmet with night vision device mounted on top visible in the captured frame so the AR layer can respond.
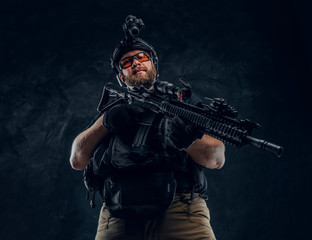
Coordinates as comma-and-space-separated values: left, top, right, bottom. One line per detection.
111, 15, 158, 86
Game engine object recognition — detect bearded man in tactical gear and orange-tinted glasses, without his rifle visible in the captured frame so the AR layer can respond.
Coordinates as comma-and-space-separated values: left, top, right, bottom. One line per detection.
70, 16, 225, 240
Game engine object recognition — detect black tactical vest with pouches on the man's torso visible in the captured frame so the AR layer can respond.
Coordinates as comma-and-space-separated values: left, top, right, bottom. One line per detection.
85, 91, 207, 219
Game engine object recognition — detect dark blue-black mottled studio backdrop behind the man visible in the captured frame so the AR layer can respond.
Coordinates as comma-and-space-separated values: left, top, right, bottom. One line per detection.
0, 0, 312, 240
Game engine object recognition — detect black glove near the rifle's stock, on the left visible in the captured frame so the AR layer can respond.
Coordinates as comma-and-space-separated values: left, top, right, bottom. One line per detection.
103, 104, 144, 133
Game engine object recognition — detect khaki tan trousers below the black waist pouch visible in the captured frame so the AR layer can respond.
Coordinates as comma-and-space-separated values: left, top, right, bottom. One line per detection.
95, 193, 216, 240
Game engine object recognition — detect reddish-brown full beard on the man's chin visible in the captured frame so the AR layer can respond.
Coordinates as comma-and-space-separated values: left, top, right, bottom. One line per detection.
124, 67, 156, 89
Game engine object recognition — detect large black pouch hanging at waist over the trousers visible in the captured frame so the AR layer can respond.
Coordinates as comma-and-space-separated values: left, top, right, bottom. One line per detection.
104, 172, 176, 220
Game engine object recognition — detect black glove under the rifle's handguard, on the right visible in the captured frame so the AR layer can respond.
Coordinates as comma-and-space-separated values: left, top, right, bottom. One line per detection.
168, 116, 203, 150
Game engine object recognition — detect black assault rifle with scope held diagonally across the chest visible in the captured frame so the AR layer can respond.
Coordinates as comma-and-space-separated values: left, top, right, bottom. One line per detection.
97, 79, 283, 157
